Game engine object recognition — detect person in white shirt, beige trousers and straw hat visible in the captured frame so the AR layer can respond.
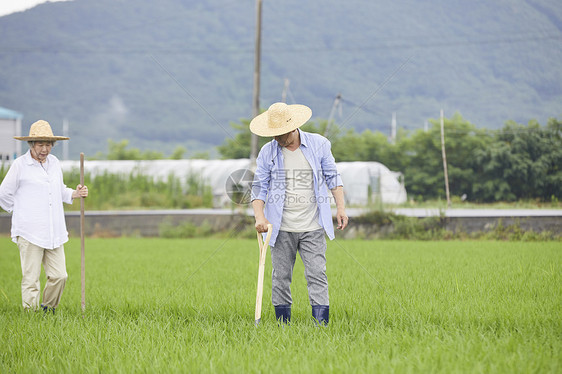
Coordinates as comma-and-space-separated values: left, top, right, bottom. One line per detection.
0, 121, 88, 313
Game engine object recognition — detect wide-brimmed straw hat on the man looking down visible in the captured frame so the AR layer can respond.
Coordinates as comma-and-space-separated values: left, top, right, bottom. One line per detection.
250, 103, 312, 136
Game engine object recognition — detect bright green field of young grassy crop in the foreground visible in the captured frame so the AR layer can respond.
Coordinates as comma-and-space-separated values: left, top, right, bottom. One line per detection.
0, 237, 562, 373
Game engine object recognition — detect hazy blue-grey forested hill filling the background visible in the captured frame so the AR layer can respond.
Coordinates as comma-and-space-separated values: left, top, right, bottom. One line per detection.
0, 0, 562, 158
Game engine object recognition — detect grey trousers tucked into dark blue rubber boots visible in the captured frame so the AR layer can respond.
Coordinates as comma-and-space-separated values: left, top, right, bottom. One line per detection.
271, 229, 330, 306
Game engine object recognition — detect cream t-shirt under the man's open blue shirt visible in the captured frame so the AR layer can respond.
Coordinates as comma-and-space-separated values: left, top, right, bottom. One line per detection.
280, 147, 322, 232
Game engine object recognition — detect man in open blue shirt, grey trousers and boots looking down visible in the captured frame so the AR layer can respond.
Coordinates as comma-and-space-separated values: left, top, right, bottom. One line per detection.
250, 103, 348, 325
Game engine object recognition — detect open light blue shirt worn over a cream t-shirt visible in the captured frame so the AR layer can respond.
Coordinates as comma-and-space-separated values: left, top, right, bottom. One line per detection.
252, 129, 343, 247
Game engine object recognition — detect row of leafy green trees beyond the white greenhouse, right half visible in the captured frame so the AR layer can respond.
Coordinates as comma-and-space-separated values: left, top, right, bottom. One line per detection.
218, 113, 562, 202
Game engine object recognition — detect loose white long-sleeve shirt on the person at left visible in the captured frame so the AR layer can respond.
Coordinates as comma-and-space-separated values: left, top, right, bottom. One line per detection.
0, 151, 73, 249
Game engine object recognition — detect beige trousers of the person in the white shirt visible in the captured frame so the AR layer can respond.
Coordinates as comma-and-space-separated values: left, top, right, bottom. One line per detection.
18, 236, 68, 310
